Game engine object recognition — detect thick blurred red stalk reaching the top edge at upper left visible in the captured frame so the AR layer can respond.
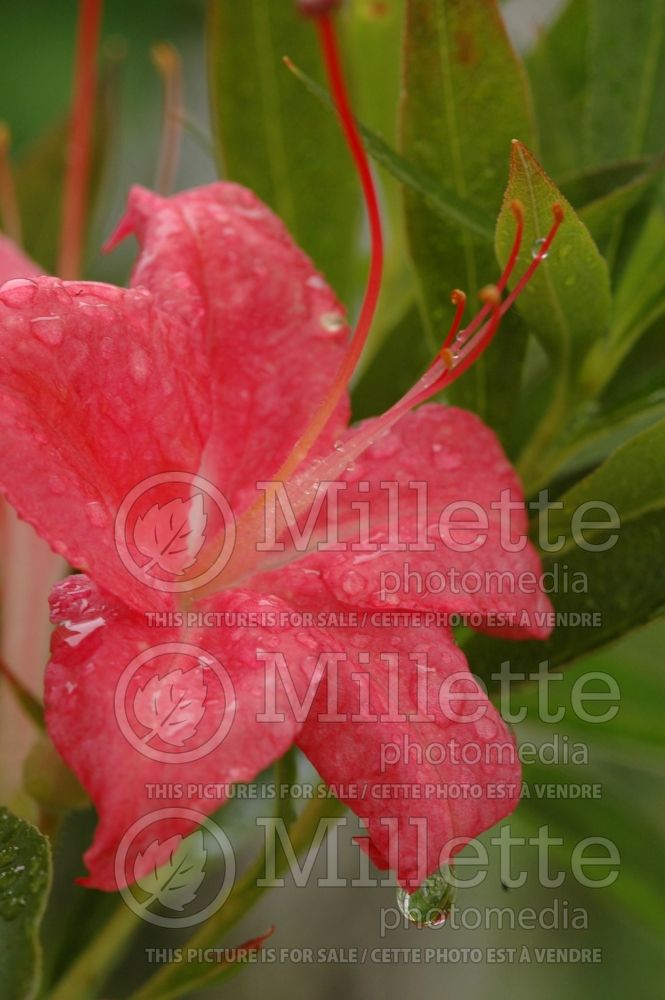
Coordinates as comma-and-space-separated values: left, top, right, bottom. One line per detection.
58, 0, 103, 279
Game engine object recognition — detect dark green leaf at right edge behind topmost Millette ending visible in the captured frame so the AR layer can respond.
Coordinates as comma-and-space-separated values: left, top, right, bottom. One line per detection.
465, 420, 665, 677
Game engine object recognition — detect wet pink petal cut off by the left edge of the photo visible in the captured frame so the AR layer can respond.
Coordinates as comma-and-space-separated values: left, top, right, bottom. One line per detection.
0, 278, 208, 608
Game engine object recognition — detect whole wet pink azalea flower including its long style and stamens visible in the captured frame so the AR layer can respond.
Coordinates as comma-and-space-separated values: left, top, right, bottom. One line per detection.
0, 5, 561, 890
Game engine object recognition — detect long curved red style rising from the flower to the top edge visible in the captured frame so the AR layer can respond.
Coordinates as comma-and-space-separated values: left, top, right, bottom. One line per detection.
274, 2, 383, 480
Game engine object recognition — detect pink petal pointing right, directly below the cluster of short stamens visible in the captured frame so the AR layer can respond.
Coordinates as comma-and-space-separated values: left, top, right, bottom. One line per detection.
278, 404, 551, 638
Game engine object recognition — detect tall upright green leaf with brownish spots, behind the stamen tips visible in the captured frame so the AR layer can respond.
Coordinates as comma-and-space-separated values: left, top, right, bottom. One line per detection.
401, 0, 534, 431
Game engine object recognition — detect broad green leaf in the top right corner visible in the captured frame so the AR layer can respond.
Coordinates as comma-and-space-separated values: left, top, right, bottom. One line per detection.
585, 0, 665, 164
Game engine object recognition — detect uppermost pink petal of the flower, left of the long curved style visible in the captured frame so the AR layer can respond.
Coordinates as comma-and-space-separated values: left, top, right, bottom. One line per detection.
114, 183, 348, 513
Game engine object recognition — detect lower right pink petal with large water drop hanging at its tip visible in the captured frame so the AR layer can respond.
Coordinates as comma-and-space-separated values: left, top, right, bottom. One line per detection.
254, 567, 521, 889
